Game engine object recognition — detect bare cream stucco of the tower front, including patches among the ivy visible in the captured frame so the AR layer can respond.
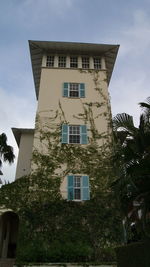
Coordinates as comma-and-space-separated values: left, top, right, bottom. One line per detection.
33, 68, 109, 198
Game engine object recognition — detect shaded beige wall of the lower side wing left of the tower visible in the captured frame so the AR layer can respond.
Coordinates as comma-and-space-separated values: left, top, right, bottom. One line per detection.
16, 133, 33, 179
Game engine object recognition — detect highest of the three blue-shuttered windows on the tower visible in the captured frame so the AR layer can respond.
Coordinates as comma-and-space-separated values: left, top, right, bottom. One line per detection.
63, 83, 85, 98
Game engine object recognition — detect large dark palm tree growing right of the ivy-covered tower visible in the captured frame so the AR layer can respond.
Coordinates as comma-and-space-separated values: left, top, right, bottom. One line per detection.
113, 97, 150, 241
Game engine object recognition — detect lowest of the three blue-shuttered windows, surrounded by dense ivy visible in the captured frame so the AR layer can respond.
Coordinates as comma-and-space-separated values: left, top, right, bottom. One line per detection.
67, 175, 90, 200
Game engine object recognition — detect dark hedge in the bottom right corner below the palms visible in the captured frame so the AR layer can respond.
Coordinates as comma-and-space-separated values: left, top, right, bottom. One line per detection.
116, 241, 150, 267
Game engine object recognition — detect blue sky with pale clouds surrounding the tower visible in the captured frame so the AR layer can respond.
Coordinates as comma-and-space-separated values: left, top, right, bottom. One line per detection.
0, 0, 150, 182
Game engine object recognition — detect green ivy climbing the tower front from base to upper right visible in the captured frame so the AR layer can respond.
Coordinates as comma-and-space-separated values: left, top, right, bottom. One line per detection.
0, 69, 121, 262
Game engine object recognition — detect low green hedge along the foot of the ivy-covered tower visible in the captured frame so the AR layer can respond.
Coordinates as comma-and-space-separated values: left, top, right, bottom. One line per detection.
17, 240, 93, 262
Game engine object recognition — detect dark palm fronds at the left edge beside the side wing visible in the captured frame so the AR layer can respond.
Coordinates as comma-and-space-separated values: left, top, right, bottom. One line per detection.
0, 133, 15, 172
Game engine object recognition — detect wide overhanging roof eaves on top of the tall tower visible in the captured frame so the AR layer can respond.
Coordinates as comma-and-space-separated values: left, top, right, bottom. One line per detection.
29, 40, 119, 98
